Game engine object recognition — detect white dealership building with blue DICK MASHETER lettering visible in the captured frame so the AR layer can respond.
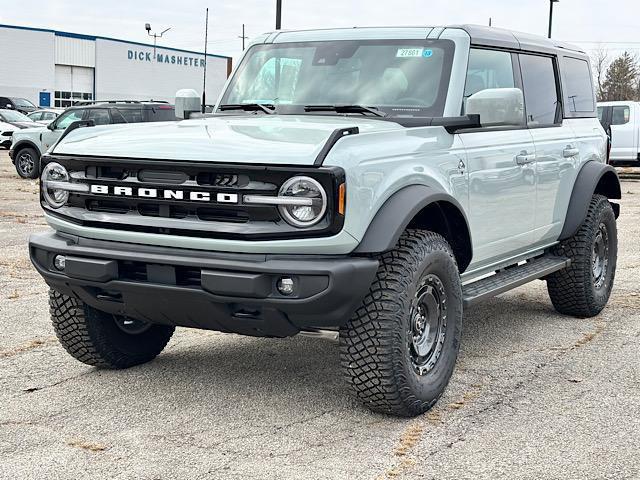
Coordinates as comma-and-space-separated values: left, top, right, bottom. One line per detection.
0, 25, 231, 107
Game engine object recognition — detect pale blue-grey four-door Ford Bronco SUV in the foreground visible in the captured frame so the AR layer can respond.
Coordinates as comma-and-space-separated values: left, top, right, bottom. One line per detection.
30, 26, 621, 416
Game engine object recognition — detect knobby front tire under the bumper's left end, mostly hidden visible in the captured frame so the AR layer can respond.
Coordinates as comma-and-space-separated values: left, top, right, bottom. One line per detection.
49, 289, 175, 369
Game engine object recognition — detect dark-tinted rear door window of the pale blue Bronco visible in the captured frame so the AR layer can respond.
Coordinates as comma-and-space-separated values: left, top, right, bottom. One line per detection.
520, 55, 560, 127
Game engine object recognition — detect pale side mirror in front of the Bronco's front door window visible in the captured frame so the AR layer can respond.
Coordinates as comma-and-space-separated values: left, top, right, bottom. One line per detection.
465, 88, 525, 127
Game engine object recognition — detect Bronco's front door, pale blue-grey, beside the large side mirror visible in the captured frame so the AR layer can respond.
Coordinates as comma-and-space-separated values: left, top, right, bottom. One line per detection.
460, 48, 536, 268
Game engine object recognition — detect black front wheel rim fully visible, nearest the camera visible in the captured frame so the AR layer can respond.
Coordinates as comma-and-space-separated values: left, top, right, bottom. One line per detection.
408, 274, 447, 375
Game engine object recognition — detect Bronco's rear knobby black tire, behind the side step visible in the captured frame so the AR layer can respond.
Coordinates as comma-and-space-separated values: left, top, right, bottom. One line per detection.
547, 195, 618, 318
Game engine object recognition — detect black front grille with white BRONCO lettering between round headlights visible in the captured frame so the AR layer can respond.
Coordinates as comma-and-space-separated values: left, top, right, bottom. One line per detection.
42, 155, 344, 239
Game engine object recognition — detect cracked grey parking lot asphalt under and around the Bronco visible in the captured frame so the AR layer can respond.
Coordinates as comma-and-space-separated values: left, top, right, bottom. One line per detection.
0, 150, 640, 479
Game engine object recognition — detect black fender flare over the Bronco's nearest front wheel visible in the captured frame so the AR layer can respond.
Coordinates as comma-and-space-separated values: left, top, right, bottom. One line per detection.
354, 185, 471, 259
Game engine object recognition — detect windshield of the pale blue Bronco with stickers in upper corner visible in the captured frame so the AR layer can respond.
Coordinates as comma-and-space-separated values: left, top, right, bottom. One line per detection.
220, 40, 454, 116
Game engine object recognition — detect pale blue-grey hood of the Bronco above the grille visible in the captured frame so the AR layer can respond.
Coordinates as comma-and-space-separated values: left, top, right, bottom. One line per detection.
53, 114, 403, 165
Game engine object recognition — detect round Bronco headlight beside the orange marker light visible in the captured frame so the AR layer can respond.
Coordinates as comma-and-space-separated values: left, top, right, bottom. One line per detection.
278, 177, 327, 227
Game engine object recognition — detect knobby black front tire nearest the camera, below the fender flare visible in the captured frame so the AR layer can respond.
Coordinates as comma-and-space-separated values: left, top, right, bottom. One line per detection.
340, 230, 462, 416
